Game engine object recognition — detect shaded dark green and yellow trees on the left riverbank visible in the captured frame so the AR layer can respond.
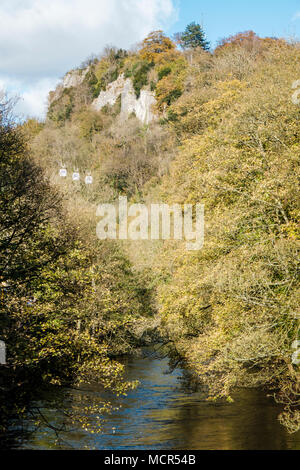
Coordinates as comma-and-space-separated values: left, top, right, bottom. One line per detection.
0, 95, 142, 442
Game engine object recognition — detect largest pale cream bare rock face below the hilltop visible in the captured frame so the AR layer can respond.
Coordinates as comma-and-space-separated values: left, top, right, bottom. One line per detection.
92, 74, 156, 124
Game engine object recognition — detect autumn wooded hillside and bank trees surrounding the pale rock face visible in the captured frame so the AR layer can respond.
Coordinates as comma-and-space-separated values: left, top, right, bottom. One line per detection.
1, 32, 300, 438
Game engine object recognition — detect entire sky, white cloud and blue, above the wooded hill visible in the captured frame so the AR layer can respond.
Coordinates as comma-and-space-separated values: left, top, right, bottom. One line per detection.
0, 0, 300, 119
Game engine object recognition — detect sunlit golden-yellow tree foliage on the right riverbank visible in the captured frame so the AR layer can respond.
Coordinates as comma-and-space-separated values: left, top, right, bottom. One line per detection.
150, 39, 300, 418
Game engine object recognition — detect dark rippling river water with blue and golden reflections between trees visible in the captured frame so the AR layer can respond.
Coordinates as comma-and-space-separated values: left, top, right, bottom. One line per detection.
19, 351, 300, 450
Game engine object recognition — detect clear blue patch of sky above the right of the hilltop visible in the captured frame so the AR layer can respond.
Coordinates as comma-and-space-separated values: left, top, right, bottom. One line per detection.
167, 0, 300, 45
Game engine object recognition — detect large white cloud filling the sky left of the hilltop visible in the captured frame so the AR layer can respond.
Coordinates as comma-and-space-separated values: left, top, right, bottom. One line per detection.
0, 0, 176, 115
